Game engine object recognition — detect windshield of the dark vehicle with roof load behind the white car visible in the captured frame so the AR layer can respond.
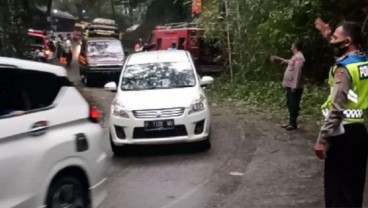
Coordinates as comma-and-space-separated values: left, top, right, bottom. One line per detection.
87, 41, 123, 56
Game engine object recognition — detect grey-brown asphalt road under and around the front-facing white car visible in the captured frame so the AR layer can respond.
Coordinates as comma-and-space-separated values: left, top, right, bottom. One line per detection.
63, 47, 368, 208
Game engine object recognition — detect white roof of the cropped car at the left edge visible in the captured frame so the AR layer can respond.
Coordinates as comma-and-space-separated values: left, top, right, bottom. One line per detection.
0, 57, 67, 77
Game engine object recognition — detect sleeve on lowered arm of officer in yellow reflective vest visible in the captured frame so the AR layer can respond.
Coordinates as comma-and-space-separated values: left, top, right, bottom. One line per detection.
319, 67, 352, 141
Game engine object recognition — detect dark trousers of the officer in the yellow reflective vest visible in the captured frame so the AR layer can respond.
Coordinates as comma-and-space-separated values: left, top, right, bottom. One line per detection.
324, 124, 368, 207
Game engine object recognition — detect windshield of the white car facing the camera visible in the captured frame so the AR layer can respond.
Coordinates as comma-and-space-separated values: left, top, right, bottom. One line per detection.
121, 62, 196, 90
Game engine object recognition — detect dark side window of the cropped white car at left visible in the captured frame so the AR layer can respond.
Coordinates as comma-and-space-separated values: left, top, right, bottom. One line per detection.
0, 66, 71, 119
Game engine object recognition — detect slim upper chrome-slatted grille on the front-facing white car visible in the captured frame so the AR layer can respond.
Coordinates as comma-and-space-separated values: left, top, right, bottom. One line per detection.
133, 108, 185, 118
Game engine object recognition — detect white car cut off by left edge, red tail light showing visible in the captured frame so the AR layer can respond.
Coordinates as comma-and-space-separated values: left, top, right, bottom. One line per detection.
0, 57, 107, 208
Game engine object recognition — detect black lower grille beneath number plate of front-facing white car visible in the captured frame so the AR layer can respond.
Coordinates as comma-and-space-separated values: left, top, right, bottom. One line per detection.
133, 125, 188, 139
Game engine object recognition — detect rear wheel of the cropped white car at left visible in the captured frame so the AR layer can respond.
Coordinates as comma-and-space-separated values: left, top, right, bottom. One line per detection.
46, 176, 90, 208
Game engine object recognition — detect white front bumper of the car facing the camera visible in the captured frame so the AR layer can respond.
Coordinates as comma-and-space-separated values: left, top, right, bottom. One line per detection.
110, 109, 210, 146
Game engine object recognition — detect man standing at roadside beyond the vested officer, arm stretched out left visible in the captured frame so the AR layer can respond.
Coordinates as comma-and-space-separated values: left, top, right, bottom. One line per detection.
271, 41, 305, 131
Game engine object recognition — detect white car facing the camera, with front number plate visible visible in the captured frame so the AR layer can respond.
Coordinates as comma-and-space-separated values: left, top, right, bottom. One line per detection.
105, 50, 213, 154
